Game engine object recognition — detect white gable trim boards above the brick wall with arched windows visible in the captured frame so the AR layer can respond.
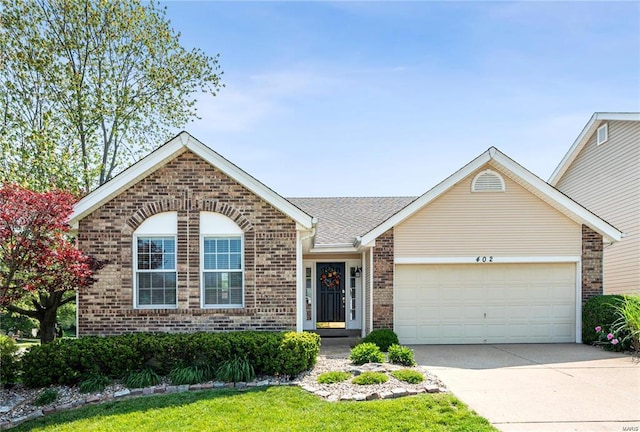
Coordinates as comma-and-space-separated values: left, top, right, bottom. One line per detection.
70, 131, 315, 229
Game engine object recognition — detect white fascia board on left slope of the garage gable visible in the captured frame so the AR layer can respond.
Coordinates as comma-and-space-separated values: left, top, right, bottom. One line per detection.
361, 147, 495, 245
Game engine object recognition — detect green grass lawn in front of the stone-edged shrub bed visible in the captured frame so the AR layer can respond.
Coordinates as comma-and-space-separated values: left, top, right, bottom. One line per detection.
12, 387, 496, 432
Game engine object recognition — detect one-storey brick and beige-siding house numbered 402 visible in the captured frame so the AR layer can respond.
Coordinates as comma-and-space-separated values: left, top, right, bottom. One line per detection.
71, 132, 621, 344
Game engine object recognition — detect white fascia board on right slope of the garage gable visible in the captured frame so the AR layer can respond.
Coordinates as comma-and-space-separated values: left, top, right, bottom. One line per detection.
493, 151, 622, 241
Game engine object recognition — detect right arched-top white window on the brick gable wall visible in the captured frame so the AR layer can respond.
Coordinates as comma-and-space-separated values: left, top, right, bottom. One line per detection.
200, 212, 244, 308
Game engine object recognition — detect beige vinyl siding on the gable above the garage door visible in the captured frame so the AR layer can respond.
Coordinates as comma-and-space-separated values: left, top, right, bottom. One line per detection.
395, 165, 582, 258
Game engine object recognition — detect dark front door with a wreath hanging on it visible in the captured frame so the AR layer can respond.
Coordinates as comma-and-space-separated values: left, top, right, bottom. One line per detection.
316, 263, 346, 323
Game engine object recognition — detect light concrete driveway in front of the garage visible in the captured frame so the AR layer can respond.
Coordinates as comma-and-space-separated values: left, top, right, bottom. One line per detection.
411, 344, 640, 432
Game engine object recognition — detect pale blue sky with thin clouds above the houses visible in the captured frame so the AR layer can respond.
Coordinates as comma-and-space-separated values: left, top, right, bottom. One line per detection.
162, 1, 640, 196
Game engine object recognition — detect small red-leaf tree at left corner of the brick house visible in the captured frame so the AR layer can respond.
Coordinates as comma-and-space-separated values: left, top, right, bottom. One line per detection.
0, 184, 103, 343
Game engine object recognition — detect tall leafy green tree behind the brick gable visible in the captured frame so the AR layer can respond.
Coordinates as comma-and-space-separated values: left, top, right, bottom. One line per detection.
0, 0, 223, 191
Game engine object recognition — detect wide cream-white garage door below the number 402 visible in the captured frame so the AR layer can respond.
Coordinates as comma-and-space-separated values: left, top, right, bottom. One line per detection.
394, 263, 576, 344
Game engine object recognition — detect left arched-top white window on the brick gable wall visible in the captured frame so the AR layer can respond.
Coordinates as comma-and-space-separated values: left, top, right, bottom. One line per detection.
133, 212, 178, 309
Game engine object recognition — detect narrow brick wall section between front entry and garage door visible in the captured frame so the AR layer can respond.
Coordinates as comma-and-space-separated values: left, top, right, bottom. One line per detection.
373, 228, 393, 329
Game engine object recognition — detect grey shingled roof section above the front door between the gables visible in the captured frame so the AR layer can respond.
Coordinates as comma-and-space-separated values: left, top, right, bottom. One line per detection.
287, 197, 416, 247
